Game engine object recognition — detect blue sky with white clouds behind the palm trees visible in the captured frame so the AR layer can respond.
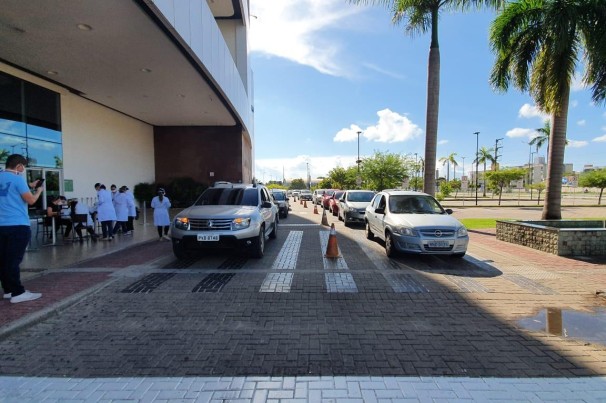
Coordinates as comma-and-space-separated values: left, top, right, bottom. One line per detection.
249, 0, 606, 182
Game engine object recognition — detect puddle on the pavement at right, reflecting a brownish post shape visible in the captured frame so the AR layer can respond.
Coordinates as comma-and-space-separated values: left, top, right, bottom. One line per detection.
517, 308, 606, 346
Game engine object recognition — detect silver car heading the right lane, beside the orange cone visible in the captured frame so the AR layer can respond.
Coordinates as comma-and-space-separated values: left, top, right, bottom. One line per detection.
364, 190, 469, 257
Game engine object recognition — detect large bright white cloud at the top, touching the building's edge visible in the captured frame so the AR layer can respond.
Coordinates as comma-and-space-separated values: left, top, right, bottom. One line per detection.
250, 0, 364, 76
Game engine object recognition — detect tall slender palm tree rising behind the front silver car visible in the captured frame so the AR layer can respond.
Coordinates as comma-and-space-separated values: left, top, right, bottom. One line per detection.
350, 0, 505, 196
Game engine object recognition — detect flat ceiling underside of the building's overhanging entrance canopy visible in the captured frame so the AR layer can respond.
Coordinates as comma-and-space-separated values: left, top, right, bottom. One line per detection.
0, 0, 236, 126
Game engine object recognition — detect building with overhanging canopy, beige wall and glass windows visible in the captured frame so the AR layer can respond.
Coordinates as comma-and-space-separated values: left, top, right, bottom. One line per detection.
0, 0, 254, 207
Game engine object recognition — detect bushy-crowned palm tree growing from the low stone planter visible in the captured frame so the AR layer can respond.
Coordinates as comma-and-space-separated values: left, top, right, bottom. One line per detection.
490, 0, 606, 219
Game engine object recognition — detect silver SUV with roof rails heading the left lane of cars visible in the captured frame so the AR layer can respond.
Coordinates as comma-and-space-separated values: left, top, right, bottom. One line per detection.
170, 182, 278, 259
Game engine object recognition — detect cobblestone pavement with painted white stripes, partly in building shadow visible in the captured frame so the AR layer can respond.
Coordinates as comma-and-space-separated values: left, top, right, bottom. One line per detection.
0, 204, 606, 402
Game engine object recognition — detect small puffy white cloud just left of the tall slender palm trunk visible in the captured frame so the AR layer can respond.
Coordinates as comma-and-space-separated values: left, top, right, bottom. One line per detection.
333, 109, 423, 143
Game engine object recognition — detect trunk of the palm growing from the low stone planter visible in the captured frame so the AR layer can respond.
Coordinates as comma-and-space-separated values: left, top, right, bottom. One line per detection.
542, 87, 570, 220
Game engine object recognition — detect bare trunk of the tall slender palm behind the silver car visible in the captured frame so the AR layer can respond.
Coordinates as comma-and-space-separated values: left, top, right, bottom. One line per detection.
423, 8, 440, 196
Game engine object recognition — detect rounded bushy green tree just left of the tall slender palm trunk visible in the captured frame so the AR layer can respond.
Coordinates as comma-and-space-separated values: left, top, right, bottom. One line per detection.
360, 151, 408, 191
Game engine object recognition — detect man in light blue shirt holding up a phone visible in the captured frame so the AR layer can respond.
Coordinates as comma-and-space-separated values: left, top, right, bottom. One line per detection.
0, 154, 43, 304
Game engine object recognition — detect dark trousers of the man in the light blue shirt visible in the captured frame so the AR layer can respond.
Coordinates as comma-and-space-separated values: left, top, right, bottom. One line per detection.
0, 225, 31, 297
